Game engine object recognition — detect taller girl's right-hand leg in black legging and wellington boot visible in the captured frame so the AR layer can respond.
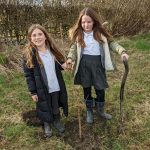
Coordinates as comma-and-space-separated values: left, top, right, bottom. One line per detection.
95, 89, 112, 120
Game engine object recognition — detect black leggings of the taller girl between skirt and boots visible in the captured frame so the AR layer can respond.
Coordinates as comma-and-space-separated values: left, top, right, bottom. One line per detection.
83, 87, 105, 102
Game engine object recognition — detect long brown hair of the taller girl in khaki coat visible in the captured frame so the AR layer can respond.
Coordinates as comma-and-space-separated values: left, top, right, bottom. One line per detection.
69, 7, 112, 48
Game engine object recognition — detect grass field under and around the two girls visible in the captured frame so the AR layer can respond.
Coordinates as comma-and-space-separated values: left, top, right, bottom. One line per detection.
0, 34, 150, 150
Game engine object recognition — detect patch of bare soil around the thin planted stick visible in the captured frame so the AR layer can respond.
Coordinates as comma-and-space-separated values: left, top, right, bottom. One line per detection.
64, 118, 103, 150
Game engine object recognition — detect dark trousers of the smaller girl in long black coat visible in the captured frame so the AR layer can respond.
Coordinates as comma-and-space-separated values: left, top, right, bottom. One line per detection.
48, 91, 60, 115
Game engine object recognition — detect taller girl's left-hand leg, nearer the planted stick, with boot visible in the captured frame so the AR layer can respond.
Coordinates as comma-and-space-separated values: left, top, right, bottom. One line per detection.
83, 87, 94, 124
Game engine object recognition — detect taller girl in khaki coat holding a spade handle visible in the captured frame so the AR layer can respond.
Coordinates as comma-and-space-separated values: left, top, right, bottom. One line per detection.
66, 8, 128, 124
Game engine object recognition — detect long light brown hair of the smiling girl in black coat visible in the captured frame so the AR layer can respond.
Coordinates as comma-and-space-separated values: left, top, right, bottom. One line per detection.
24, 24, 65, 68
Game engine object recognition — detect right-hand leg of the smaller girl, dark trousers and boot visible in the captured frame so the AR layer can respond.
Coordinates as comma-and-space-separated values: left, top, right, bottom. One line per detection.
51, 92, 65, 133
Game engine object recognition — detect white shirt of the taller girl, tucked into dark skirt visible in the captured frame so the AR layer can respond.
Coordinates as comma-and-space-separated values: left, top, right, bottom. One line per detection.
82, 31, 100, 55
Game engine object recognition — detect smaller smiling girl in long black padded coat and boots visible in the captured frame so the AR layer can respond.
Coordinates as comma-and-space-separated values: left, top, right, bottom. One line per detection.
23, 24, 68, 137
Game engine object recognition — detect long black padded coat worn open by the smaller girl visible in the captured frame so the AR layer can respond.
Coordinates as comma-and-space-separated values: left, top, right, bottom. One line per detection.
23, 50, 68, 122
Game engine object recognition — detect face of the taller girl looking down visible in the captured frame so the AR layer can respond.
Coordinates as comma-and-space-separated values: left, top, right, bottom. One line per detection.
81, 15, 94, 33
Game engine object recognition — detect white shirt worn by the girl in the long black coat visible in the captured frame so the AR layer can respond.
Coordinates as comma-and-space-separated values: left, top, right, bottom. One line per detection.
38, 50, 60, 93
